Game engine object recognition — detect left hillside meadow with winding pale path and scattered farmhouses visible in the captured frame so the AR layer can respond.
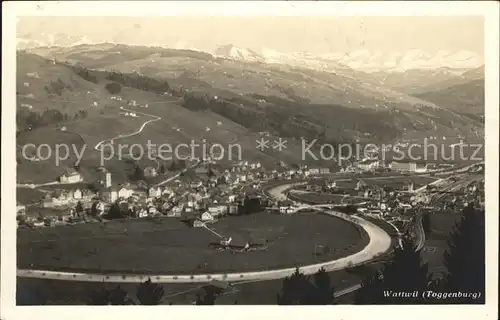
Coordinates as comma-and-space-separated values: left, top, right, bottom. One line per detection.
17, 53, 324, 183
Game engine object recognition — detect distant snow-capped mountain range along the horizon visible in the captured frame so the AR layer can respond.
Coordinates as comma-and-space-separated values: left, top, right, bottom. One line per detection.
17, 33, 484, 72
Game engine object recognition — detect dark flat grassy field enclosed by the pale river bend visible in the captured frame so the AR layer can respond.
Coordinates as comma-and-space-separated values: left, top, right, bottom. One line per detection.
18, 213, 368, 274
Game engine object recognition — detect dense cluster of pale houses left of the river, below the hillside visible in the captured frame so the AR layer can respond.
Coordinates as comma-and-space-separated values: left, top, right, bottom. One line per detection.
18, 161, 278, 225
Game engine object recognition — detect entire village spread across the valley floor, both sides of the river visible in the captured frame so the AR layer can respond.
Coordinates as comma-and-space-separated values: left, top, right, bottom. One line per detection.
17, 151, 484, 248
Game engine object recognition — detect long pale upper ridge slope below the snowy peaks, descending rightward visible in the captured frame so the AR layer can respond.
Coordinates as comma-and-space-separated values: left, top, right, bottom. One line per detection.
27, 44, 442, 109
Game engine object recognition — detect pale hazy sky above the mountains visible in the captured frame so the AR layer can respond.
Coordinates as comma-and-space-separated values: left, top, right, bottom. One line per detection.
17, 16, 483, 55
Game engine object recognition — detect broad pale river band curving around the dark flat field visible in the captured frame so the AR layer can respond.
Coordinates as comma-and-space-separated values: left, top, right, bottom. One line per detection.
17, 181, 391, 284
